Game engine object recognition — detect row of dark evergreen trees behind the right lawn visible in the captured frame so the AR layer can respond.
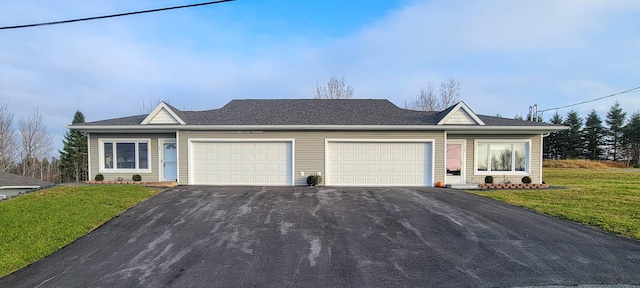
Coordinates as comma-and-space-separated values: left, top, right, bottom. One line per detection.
543, 102, 640, 166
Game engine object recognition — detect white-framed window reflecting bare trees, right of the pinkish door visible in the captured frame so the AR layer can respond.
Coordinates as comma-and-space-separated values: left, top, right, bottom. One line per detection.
475, 140, 530, 174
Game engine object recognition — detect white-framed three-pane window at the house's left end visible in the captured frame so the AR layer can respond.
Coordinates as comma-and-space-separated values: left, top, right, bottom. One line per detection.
99, 139, 151, 171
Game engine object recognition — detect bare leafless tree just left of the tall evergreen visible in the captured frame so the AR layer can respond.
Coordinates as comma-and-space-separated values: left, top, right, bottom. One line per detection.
18, 110, 53, 178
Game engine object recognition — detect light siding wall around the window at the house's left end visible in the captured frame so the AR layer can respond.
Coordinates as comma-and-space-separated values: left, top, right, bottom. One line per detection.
88, 133, 175, 182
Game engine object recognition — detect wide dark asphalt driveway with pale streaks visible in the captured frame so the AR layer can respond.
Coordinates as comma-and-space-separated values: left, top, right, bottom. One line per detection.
0, 186, 640, 287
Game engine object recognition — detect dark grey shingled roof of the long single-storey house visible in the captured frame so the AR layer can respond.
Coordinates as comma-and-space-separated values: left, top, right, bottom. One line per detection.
71, 99, 553, 127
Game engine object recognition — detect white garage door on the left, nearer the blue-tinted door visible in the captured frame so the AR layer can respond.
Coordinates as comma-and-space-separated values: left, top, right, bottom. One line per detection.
189, 141, 293, 185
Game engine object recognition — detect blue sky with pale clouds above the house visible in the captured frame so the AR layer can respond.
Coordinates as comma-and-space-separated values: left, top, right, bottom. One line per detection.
0, 0, 640, 154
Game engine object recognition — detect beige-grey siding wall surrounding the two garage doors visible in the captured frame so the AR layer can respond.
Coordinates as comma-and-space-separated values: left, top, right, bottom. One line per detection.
178, 131, 444, 185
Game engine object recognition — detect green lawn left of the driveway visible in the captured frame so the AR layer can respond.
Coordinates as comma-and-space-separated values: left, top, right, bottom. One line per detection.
0, 185, 161, 277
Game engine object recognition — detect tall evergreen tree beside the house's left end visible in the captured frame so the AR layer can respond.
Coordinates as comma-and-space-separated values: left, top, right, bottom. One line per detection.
59, 111, 89, 182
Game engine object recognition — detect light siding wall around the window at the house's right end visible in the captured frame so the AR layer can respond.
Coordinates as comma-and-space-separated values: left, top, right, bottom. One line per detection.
448, 135, 542, 184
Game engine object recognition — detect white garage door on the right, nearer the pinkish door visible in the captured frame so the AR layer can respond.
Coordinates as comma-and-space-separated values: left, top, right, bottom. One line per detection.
326, 142, 433, 186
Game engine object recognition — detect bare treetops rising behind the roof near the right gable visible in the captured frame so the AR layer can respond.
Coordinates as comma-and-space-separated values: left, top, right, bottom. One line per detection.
403, 79, 461, 111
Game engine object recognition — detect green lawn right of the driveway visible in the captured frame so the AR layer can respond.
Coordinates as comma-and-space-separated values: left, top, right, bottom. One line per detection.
474, 168, 640, 240
